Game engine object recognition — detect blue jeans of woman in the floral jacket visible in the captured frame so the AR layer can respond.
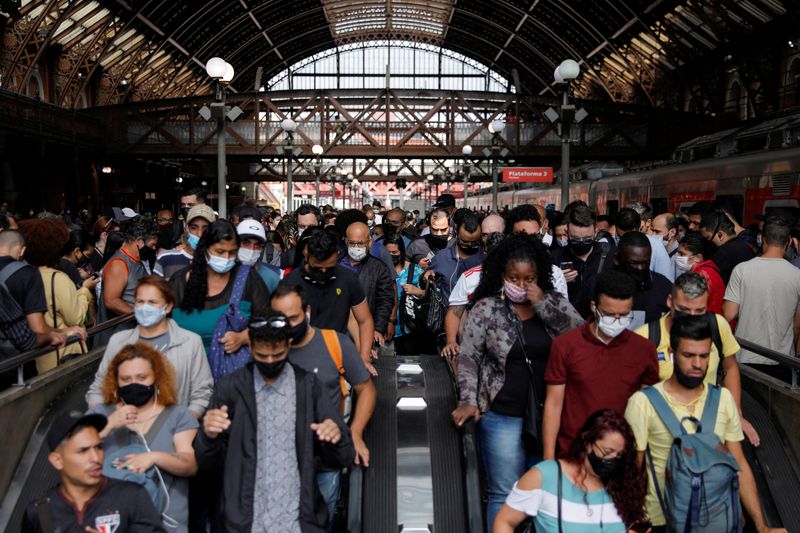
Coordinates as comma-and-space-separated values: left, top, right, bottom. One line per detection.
478, 411, 538, 532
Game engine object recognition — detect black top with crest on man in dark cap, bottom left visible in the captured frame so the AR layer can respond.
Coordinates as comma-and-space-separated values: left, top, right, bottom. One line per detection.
22, 478, 165, 533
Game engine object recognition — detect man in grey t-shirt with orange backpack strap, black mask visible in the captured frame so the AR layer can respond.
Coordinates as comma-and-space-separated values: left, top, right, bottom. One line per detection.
271, 285, 377, 518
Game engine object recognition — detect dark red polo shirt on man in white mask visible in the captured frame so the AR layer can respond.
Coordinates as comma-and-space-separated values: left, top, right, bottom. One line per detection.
544, 322, 658, 454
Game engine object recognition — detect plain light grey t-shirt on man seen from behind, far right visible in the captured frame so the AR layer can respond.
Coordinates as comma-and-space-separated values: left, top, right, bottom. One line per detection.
725, 257, 800, 365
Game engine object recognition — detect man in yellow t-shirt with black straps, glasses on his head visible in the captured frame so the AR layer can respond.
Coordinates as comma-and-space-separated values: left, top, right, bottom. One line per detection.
635, 272, 760, 446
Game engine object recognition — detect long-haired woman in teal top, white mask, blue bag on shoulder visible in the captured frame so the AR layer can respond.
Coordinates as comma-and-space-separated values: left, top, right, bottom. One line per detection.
170, 220, 269, 380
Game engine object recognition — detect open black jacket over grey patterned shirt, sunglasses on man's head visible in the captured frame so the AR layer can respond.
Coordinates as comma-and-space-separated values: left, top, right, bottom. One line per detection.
194, 362, 355, 533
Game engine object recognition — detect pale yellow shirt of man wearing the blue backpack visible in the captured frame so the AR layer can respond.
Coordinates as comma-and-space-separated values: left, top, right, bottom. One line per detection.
625, 381, 744, 526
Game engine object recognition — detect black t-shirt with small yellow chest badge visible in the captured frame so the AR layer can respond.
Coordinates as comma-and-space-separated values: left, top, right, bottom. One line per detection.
281, 265, 367, 334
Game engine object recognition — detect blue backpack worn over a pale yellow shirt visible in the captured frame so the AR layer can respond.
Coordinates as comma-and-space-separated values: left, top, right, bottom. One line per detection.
642, 385, 744, 533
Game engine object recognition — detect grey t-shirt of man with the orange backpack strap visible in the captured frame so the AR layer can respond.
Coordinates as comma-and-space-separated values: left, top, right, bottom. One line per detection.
289, 330, 370, 411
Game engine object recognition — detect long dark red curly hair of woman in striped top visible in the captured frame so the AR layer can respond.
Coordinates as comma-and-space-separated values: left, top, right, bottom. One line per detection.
564, 409, 647, 527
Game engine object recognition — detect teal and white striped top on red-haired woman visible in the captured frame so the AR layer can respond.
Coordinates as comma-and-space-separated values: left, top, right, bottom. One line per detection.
506, 460, 626, 533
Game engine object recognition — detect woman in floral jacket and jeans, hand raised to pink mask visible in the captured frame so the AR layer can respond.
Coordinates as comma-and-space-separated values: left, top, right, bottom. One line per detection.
453, 234, 583, 525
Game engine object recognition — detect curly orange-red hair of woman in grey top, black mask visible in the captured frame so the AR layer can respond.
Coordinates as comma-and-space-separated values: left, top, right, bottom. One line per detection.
101, 342, 178, 405
